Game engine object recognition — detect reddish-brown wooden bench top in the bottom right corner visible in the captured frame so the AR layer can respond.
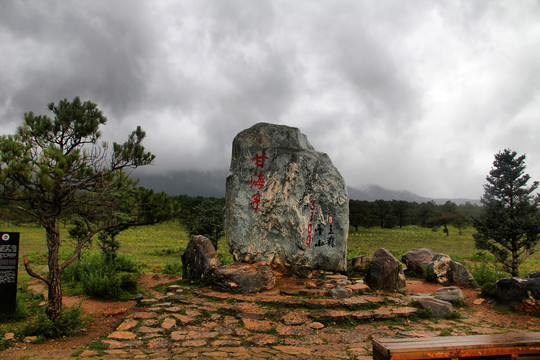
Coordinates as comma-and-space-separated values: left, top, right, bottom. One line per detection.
372, 332, 540, 360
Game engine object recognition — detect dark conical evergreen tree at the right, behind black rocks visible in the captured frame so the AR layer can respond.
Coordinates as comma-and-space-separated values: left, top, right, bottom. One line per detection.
473, 149, 540, 276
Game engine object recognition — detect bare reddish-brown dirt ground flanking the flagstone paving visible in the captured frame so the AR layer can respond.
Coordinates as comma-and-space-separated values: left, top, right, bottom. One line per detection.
4, 275, 540, 359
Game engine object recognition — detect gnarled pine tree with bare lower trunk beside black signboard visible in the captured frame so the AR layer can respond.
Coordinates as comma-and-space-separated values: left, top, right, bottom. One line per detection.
0, 97, 160, 321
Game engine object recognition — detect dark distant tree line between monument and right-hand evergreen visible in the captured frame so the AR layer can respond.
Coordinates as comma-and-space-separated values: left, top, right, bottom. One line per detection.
349, 200, 484, 231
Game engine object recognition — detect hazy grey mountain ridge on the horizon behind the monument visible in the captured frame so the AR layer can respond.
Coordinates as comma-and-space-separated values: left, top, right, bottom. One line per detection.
136, 170, 480, 205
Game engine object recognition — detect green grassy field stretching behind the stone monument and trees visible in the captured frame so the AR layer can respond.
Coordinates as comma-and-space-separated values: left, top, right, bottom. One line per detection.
4, 222, 540, 282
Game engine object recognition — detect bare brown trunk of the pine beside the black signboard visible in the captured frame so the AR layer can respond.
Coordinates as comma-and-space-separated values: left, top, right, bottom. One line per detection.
45, 222, 62, 321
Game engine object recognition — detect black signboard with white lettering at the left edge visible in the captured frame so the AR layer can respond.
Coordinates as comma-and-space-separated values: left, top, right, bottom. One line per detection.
0, 232, 19, 313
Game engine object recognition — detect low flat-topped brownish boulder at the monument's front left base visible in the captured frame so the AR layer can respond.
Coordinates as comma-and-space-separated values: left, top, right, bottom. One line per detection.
212, 262, 276, 294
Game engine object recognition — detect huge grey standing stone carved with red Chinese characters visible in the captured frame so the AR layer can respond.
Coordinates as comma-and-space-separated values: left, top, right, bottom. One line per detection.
224, 123, 349, 273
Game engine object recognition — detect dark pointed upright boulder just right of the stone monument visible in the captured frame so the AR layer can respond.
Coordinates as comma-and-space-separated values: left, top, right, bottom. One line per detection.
364, 248, 407, 290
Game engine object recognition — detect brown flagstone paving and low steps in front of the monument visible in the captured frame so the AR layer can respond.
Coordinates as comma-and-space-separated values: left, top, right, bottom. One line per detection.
0, 278, 540, 360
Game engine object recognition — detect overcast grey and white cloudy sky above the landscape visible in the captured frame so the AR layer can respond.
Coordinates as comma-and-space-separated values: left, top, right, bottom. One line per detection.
0, 0, 540, 199
